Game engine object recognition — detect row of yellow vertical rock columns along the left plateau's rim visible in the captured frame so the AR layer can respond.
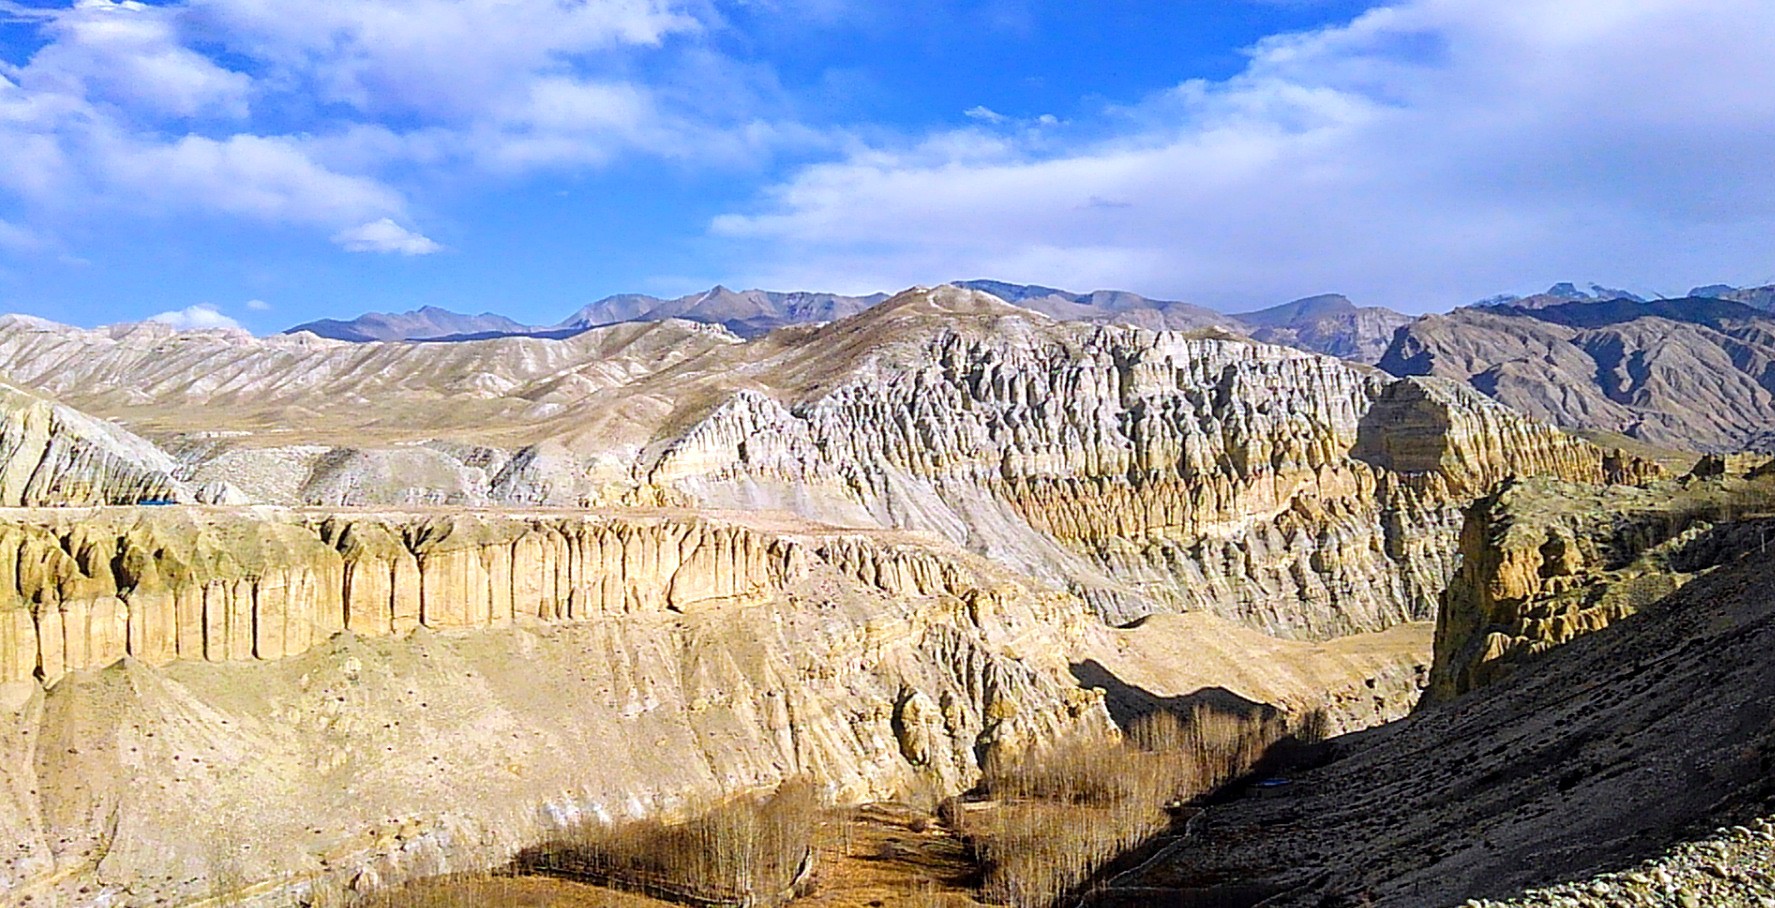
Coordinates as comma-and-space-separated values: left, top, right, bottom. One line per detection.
0, 509, 1079, 685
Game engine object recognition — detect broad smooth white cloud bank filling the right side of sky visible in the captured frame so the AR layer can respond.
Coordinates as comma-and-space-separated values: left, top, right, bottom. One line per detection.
712, 0, 1775, 309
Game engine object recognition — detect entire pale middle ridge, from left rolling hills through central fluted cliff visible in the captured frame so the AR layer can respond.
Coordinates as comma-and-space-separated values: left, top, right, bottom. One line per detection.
0, 287, 1621, 637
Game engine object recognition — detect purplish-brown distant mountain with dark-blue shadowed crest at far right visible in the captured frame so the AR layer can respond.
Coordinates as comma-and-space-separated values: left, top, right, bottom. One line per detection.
1381, 300, 1775, 450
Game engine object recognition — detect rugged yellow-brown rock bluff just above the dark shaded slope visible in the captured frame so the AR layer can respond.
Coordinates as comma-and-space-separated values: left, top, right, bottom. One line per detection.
1425, 474, 1775, 702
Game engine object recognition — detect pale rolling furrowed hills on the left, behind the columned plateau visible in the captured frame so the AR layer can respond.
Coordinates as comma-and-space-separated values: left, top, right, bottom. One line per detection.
0, 317, 738, 447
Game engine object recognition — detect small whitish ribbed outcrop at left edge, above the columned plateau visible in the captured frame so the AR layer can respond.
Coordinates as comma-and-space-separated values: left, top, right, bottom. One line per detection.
0, 375, 192, 507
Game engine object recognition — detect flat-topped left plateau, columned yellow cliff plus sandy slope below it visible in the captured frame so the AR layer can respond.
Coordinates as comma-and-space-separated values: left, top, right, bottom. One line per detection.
0, 509, 1108, 903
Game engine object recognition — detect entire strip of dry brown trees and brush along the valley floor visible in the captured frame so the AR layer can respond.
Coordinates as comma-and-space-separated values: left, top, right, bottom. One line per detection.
333, 706, 1324, 908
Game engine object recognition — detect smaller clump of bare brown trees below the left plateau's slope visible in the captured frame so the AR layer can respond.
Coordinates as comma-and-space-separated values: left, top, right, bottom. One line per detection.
517, 780, 820, 906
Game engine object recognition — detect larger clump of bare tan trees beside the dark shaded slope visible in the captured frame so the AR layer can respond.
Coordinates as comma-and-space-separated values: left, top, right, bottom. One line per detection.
951, 706, 1322, 908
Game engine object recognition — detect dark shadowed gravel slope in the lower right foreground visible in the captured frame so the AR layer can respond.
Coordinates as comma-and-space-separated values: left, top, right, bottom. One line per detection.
1092, 503, 1775, 908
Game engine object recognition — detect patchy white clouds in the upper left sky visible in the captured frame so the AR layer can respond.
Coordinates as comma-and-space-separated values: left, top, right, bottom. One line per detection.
0, 0, 777, 254
